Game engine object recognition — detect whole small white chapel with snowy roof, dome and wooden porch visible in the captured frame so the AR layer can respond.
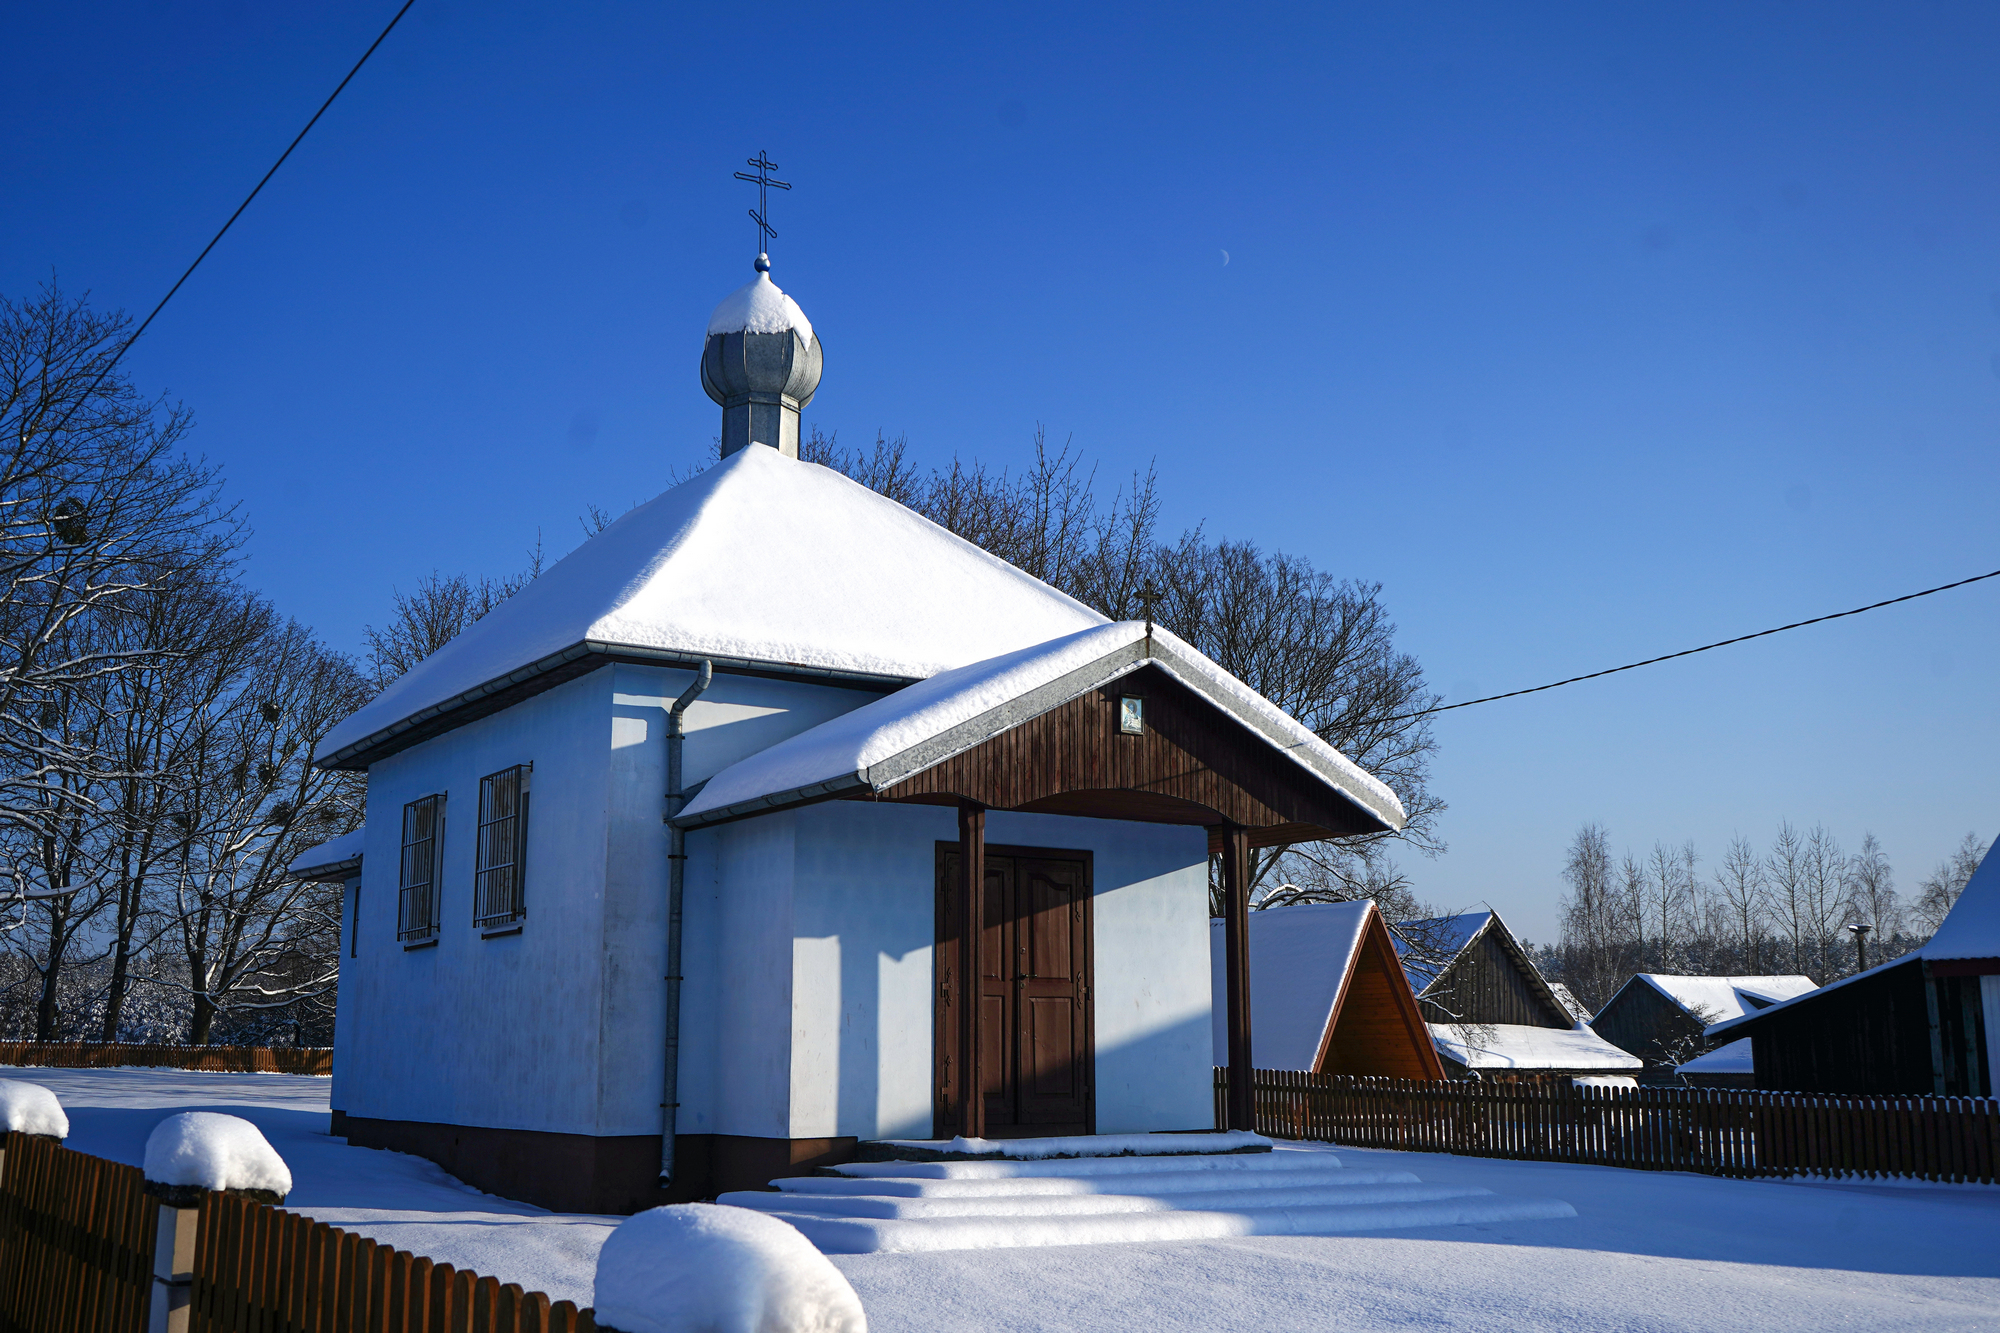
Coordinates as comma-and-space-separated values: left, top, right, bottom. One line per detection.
294, 246, 1404, 1211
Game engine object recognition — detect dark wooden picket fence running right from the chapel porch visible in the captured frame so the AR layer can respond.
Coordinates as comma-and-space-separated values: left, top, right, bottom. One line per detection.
1216, 1069, 2000, 1185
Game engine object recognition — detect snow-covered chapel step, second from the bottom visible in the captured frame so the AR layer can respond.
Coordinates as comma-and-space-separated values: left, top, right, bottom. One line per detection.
716, 1175, 1492, 1217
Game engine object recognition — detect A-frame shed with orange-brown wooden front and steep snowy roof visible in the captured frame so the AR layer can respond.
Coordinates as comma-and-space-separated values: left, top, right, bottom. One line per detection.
1210, 901, 1444, 1079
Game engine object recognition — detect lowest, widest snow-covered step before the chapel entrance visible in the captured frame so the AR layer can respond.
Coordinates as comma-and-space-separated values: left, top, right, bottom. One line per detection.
752, 1195, 1576, 1255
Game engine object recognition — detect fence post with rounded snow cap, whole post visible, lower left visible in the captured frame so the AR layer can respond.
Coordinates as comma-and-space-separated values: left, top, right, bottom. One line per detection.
146, 1111, 292, 1333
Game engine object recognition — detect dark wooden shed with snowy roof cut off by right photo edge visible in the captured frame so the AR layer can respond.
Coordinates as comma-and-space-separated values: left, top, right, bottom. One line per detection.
1708, 836, 2000, 1097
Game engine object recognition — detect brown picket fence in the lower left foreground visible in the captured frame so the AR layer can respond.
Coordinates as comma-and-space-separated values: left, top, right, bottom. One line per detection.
0, 1135, 596, 1333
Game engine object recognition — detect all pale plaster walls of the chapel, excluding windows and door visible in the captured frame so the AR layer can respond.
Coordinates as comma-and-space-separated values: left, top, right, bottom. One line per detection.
334, 667, 1212, 1139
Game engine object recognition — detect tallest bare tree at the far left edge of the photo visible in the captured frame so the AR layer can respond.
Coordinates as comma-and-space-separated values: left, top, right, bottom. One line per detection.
0, 282, 240, 1033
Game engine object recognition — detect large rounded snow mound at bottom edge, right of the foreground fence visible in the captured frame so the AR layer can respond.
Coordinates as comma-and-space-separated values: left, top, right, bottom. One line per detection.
594, 1203, 868, 1333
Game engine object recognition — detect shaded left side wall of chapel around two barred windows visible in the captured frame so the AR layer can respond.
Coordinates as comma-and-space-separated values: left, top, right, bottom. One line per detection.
332, 673, 610, 1133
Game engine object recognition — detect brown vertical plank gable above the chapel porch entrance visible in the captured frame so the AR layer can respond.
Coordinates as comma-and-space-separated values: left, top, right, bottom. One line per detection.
878, 667, 1380, 845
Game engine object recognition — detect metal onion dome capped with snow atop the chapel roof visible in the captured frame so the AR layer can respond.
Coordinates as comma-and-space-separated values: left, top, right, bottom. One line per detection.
702, 254, 822, 458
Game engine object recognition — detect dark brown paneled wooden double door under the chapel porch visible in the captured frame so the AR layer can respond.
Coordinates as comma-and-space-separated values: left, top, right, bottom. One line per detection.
932, 843, 1096, 1139
